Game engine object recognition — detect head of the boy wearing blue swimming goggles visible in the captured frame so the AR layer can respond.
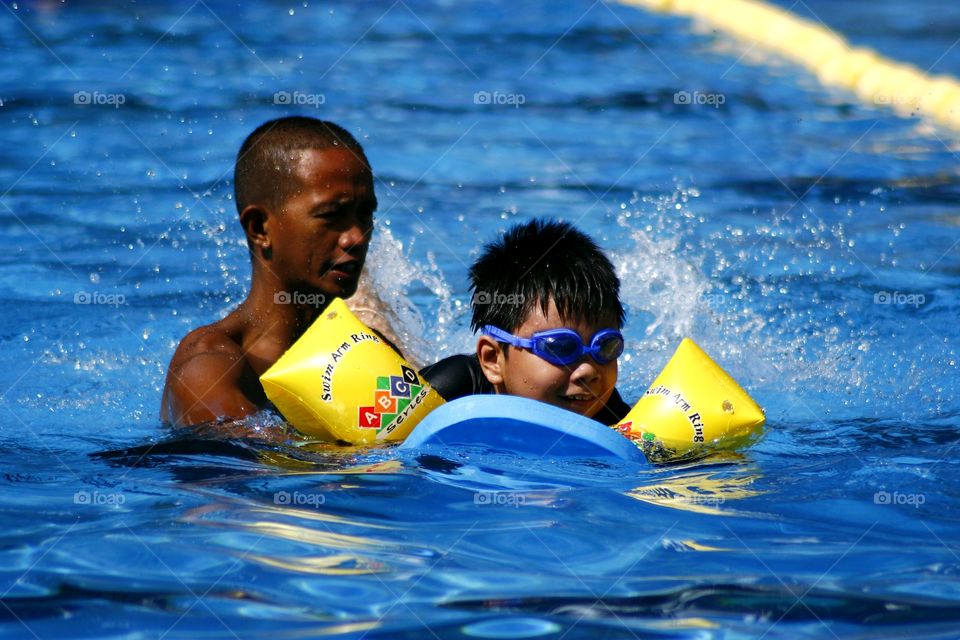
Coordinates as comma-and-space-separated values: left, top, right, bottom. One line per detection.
470, 220, 624, 417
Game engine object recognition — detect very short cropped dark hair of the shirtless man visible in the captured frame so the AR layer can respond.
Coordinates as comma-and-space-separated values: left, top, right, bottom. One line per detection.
233, 116, 370, 212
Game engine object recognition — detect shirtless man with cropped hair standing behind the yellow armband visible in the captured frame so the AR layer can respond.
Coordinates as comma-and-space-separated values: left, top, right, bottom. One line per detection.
160, 117, 377, 425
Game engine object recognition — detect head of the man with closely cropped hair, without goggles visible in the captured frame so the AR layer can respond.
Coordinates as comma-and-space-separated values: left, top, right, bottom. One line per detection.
234, 116, 377, 297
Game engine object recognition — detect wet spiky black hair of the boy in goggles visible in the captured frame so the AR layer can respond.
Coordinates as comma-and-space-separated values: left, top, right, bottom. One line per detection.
470, 219, 624, 333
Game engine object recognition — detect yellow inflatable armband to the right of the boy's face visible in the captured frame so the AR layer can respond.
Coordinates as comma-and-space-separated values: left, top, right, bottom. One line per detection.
613, 338, 765, 460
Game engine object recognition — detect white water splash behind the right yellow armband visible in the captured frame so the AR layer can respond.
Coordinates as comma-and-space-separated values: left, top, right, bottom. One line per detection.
611, 186, 869, 419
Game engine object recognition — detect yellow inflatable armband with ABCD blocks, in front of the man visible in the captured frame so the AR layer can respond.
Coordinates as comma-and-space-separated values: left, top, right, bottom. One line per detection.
260, 298, 443, 444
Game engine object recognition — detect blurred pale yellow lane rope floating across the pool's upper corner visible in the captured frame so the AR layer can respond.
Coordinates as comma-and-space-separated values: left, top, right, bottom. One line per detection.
619, 0, 960, 131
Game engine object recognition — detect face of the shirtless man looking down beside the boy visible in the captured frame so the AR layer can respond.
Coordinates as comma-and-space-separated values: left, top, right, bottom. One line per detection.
269, 148, 377, 298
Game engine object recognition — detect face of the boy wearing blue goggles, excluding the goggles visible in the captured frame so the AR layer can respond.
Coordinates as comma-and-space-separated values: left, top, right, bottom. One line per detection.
477, 299, 617, 418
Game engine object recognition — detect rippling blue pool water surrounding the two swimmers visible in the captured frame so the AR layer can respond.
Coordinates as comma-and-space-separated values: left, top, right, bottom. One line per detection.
0, 0, 960, 639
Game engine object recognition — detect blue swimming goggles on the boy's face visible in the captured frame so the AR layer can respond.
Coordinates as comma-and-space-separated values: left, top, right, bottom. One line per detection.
481, 324, 623, 366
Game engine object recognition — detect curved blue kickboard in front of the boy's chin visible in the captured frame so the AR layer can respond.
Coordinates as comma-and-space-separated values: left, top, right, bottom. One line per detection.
400, 395, 646, 462
